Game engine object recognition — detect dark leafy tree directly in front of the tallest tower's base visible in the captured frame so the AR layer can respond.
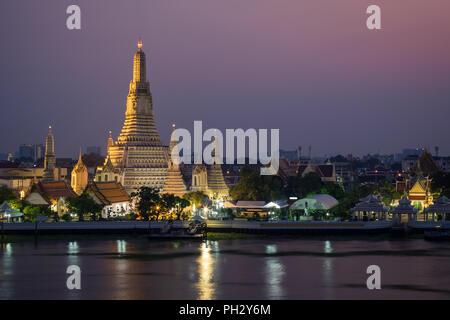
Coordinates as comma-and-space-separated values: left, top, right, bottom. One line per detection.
131, 187, 161, 220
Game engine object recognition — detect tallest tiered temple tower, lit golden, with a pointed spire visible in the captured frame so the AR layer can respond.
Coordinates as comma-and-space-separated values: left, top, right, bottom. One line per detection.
108, 41, 168, 191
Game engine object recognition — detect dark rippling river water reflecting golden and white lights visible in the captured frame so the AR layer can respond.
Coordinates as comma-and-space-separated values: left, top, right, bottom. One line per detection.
0, 238, 450, 299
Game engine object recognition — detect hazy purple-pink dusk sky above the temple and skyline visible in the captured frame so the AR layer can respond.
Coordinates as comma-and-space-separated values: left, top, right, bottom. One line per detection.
0, 0, 450, 157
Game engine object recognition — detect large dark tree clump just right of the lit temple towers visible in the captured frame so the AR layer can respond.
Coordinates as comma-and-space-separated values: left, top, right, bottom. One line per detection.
230, 167, 285, 201
